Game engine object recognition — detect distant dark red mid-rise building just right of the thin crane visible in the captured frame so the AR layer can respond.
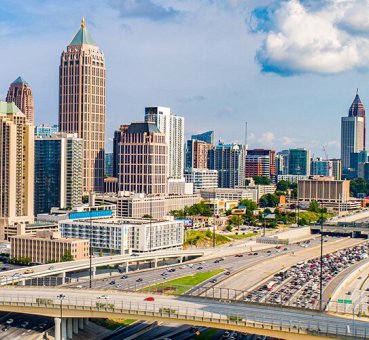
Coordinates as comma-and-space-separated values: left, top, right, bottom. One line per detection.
245, 149, 276, 179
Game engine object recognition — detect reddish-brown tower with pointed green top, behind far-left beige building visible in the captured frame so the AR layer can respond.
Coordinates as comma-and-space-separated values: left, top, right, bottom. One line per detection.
6, 77, 35, 125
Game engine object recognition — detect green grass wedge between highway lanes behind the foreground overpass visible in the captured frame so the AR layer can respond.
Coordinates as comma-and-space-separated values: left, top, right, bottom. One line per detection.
140, 269, 224, 295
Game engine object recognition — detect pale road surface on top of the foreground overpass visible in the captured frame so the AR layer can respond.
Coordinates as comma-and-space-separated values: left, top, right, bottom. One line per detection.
0, 287, 369, 339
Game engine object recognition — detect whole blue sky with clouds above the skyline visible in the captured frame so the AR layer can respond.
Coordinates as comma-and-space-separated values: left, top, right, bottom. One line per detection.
0, 0, 369, 157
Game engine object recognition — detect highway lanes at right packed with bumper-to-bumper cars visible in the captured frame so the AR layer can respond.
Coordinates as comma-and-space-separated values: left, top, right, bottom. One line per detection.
244, 239, 368, 309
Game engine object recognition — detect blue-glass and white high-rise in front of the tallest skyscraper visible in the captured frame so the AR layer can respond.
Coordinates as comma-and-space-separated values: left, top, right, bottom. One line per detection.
34, 132, 82, 215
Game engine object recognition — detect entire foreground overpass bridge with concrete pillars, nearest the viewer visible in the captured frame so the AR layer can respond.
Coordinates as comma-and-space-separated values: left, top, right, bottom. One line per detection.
0, 287, 369, 340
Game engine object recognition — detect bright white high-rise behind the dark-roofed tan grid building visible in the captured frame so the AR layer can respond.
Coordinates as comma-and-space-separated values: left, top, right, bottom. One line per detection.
145, 106, 185, 178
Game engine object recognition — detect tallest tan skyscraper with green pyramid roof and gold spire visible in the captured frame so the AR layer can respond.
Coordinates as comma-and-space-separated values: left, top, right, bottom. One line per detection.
59, 19, 106, 193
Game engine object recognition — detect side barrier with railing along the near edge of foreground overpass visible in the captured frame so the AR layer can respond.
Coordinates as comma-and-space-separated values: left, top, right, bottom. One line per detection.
0, 295, 369, 339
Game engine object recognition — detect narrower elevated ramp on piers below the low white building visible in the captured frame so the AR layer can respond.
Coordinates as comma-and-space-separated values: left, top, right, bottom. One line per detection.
0, 250, 205, 286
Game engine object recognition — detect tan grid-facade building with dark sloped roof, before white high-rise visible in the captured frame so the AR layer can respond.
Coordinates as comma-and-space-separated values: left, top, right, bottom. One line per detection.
118, 123, 168, 195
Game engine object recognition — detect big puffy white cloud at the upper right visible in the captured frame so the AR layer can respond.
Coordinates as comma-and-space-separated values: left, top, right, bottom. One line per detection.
250, 0, 369, 75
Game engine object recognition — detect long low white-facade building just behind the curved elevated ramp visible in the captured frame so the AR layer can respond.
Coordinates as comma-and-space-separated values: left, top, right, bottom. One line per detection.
59, 218, 184, 254
